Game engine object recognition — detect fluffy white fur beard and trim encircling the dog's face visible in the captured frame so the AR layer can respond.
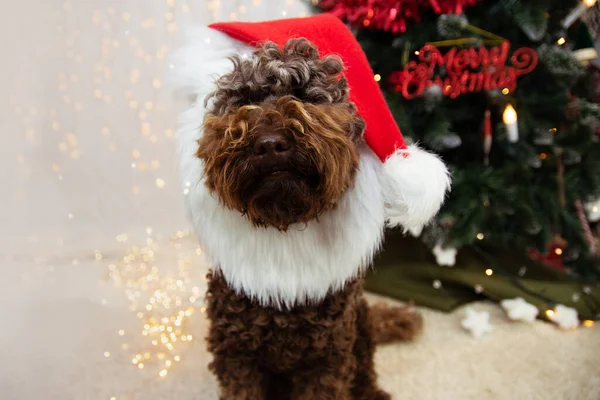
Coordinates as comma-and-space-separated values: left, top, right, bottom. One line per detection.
171, 30, 385, 307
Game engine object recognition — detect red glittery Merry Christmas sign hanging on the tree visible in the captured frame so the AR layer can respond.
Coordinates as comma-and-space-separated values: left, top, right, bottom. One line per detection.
389, 41, 538, 99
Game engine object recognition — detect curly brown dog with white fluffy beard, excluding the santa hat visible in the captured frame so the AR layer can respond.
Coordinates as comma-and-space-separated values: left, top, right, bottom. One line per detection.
189, 39, 421, 400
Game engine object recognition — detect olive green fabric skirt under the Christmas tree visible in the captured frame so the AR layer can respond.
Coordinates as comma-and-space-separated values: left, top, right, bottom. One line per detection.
366, 231, 600, 320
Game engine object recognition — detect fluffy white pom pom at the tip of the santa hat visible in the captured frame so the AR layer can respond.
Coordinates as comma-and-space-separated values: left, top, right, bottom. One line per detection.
383, 145, 450, 232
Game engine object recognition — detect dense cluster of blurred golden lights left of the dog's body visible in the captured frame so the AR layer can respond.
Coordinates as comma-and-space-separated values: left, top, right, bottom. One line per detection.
101, 230, 205, 379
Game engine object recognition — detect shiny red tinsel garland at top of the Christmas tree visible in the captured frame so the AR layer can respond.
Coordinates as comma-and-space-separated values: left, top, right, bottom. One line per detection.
319, 0, 480, 33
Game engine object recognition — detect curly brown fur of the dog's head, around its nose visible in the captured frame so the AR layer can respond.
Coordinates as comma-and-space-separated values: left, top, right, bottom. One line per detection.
197, 39, 365, 230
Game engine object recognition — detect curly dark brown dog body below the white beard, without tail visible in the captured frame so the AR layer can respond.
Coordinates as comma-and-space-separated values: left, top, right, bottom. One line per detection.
207, 273, 390, 400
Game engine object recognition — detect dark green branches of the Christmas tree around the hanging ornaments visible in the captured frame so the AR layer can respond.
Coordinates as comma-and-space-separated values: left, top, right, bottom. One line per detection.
316, 0, 600, 279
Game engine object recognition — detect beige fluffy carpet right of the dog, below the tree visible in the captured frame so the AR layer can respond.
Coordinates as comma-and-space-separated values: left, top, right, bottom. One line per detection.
373, 296, 600, 400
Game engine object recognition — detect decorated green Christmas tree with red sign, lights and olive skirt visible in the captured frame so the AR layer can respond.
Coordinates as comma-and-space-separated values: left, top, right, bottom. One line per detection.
313, 0, 600, 318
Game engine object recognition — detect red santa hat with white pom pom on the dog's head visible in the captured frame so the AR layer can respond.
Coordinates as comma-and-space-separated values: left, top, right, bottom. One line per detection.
171, 14, 450, 232
